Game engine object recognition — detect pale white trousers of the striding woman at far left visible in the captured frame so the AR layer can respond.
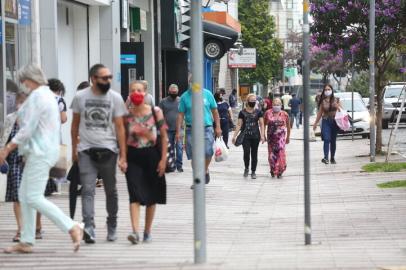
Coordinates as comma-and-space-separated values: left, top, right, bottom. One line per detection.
18, 156, 75, 244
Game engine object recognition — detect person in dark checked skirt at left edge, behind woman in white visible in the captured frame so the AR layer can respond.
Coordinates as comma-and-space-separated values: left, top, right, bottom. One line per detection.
0, 92, 27, 242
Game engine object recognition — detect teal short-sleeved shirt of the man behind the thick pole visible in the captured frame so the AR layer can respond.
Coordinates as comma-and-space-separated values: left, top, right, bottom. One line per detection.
179, 89, 217, 126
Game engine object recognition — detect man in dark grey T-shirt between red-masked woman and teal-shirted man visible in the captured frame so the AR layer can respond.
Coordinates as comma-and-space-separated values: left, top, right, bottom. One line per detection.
159, 84, 183, 172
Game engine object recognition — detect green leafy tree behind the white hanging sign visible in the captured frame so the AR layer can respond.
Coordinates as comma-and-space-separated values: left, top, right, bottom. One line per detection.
238, 0, 283, 85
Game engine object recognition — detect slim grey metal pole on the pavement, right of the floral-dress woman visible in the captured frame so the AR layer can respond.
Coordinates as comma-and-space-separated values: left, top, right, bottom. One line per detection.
303, 0, 312, 245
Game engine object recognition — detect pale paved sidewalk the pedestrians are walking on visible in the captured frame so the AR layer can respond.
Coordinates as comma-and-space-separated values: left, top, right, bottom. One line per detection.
0, 129, 406, 270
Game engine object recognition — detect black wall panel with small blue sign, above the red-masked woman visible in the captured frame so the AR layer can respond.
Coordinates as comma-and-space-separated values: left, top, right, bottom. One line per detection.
120, 42, 144, 100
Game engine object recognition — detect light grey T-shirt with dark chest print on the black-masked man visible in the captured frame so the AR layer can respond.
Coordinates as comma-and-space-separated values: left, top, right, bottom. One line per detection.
71, 87, 127, 153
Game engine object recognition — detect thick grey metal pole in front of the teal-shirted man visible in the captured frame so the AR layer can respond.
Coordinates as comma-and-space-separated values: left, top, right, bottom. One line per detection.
190, 1, 206, 264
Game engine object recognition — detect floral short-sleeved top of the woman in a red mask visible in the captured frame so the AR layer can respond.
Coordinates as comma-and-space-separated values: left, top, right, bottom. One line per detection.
125, 107, 167, 148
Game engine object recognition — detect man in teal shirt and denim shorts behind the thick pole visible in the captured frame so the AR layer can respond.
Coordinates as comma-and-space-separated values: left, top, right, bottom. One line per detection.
176, 78, 221, 187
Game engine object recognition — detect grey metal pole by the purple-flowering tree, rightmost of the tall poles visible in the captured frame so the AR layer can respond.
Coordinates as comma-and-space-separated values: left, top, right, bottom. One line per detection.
369, 0, 376, 162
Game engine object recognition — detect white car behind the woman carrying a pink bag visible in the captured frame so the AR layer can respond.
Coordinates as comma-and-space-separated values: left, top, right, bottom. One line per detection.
334, 92, 370, 138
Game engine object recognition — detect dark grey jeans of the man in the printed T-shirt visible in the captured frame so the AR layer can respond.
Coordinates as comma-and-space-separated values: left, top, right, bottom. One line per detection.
79, 152, 118, 232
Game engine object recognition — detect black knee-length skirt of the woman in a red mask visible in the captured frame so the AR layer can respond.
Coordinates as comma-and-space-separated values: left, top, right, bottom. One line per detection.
125, 146, 166, 206
